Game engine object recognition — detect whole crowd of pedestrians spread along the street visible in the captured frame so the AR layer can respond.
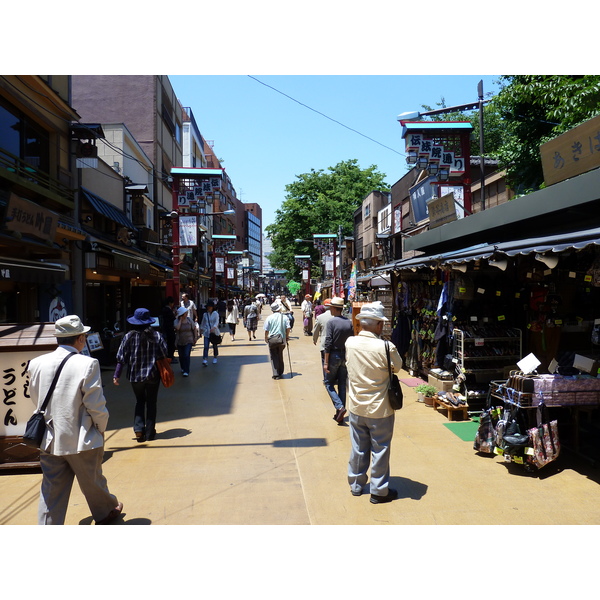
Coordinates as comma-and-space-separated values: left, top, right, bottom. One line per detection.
29, 294, 402, 524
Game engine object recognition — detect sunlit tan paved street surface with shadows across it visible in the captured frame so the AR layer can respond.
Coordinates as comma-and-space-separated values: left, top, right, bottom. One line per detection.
0, 307, 600, 528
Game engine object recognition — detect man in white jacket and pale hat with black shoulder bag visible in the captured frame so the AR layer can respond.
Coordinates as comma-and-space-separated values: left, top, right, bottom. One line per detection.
28, 315, 123, 525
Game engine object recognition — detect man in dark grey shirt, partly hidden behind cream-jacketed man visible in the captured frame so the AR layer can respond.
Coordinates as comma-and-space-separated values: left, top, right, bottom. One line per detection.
323, 298, 354, 425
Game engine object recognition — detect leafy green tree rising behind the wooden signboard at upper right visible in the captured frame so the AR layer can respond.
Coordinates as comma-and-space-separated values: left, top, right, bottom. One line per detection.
491, 75, 600, 193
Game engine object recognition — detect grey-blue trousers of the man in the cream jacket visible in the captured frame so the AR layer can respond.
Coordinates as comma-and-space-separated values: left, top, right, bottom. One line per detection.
348, 412, 395, 496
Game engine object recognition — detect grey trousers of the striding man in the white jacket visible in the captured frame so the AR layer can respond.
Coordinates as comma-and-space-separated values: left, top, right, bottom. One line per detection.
38, 448, 117, 525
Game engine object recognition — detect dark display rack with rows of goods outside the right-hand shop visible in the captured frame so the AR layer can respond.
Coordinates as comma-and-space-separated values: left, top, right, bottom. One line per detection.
452, 326, 522, 408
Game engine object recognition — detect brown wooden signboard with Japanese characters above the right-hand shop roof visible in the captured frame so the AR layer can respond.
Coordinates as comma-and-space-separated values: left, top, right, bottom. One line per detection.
540, 116, 600, 185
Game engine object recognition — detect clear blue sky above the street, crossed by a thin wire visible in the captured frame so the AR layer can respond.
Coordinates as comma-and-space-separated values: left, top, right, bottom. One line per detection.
169, 75, 498, 230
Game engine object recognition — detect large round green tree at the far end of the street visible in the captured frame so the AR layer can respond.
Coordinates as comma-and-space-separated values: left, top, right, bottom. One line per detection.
266, 159, 390, 277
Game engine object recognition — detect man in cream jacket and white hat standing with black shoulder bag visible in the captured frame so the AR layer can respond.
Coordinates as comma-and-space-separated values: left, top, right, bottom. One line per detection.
346, 302, 402, 504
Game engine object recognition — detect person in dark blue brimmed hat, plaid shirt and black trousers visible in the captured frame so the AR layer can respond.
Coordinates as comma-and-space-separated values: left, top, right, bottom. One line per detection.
113, 308, 167, 442
